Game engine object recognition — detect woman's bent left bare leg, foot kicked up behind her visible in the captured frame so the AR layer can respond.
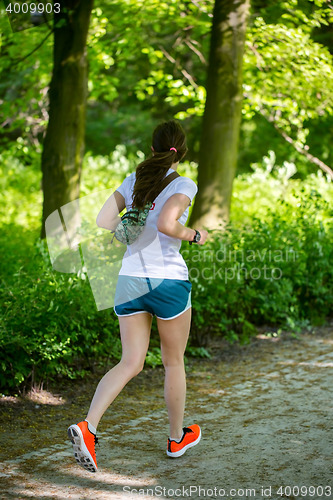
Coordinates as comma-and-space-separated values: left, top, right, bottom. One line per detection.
86, 313, 152, 428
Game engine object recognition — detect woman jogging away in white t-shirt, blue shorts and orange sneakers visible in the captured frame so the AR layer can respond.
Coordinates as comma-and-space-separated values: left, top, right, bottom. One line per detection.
68, 120, 208, 472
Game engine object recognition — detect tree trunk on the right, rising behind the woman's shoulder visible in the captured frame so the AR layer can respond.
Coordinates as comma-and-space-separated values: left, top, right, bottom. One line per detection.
191, 0, 250, 229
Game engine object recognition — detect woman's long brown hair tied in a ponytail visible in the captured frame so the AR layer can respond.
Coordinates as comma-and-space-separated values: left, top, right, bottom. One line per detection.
133, 120, 187, 208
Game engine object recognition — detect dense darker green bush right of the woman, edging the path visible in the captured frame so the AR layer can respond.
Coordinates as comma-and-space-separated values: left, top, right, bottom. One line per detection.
183, 188, 333, 345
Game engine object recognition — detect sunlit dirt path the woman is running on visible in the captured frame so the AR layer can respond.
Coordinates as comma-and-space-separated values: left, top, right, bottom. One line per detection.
0, 324, 333, 500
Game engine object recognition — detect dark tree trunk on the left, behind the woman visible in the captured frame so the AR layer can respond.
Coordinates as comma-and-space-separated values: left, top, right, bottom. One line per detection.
41, 0, 93, 238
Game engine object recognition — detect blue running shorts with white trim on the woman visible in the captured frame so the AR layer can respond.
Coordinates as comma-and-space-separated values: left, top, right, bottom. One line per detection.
114, 275, 192, 319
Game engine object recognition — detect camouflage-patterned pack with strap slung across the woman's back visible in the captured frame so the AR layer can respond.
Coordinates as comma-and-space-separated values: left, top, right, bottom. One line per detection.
114, 172, 179, 245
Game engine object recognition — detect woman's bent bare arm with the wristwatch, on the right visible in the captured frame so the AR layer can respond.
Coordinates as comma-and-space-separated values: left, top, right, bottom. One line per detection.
157, 193, 208, 245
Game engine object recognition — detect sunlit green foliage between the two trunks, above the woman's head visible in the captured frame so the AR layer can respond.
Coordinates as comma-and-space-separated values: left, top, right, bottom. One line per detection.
83, 0, 213, 154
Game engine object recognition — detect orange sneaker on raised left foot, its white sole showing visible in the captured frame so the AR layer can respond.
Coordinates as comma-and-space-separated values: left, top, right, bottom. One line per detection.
67, 420, 98, 472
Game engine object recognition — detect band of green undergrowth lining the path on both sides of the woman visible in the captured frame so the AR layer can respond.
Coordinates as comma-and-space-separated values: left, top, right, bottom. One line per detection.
0, 147, 333, 390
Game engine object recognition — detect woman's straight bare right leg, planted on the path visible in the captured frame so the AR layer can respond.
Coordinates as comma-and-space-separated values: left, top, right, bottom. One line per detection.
157, 308, 191, 440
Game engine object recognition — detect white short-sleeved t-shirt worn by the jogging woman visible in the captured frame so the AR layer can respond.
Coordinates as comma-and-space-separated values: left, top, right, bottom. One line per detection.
117, 168, 198, 280
